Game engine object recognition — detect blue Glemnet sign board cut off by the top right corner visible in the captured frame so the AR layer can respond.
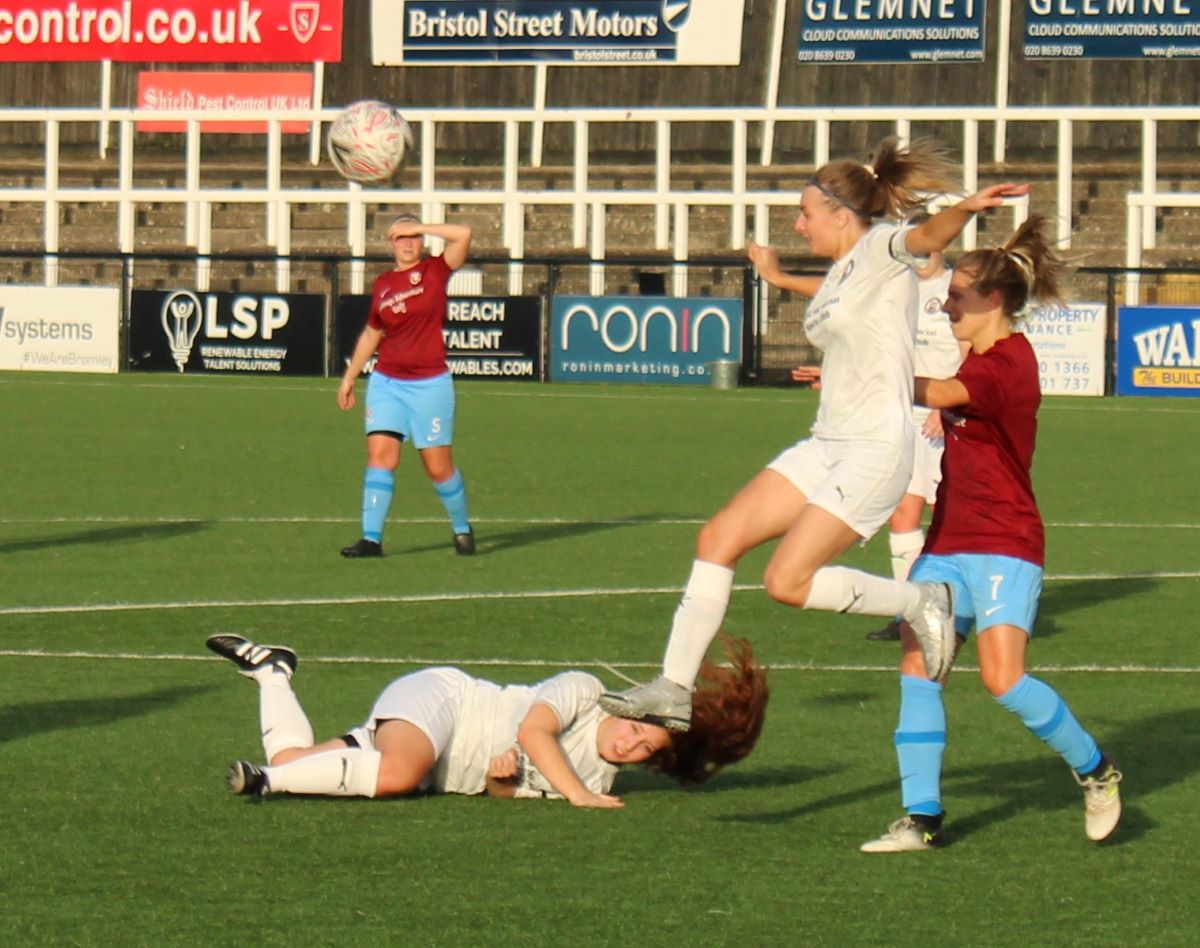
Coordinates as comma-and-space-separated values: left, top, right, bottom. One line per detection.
1025, 0, 1200, 59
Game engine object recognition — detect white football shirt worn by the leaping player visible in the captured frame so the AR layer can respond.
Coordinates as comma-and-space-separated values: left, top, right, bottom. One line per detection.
804, 222, 925, 444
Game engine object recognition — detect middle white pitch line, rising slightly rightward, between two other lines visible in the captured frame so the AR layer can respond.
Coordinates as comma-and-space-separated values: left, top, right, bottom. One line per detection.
0, 570, 1200, 617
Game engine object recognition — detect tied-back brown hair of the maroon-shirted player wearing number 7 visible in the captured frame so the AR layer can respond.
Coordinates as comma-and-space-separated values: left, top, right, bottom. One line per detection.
954, 214, 1068, 317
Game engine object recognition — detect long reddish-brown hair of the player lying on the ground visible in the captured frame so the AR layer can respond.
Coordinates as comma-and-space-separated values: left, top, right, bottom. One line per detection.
647, 635, 770, 784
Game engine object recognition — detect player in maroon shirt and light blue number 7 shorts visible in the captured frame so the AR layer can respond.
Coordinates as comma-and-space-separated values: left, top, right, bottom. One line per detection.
862, 216, 1121, 852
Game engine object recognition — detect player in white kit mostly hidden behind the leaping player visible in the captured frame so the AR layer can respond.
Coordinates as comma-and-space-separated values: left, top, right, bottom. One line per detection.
866, 248, 966, 642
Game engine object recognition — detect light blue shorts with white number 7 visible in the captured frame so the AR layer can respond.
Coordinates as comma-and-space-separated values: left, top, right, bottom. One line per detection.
908, 553, 1042, 636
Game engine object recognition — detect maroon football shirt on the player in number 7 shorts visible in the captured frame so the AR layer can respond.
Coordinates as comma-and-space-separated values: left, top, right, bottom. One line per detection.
924, 332, 1045, 566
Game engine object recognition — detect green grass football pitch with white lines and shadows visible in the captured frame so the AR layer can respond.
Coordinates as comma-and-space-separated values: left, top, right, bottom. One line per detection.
0, 374, 1200, 947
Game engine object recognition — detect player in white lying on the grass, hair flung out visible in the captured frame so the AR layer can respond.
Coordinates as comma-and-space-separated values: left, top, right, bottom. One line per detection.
208, 635, 768, 808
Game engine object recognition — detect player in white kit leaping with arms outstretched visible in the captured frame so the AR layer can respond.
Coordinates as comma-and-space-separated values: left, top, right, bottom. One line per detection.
600, 138, 1027, 731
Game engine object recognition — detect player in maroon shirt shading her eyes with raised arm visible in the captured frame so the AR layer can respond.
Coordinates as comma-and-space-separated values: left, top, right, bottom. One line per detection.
337, 215, 475, 558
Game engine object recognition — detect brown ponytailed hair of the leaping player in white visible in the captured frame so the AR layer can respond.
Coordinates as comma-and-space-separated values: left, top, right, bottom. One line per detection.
809, 136, 959, 221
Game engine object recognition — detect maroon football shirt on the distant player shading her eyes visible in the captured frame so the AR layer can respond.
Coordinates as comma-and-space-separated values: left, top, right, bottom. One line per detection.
367, 256, 451, 379
